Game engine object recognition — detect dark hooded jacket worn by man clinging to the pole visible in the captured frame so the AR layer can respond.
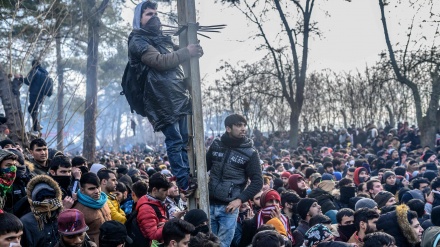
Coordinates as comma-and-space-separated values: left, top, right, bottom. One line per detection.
127, 3, 192, 131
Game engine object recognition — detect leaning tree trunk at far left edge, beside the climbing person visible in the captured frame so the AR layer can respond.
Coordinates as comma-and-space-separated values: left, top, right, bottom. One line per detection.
0, 64, 29, 146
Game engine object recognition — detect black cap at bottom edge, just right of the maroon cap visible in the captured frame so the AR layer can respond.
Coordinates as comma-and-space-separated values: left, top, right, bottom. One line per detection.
99, 220, 133, 244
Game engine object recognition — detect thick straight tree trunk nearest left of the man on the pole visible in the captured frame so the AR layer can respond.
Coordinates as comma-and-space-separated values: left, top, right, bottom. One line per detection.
83, 0, 109, 162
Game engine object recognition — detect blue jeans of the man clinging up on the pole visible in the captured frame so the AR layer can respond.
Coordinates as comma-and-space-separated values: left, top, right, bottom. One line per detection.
162, 116, 189, 190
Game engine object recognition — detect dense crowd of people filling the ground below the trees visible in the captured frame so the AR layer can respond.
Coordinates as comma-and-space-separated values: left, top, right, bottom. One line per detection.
0, 110, 440, 247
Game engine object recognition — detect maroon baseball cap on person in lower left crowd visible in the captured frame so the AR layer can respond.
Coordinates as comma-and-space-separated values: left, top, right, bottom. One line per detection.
58, 209, 89, 235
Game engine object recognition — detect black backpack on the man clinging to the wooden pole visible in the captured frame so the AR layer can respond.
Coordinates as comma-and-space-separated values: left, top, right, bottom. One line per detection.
120, 62, 147, 117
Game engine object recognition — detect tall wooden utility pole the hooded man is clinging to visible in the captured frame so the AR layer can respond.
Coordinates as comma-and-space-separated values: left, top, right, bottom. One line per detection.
177, 0, 209, 212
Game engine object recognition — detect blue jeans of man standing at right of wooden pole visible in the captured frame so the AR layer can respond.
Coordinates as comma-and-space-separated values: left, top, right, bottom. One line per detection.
209, 205, 238, 247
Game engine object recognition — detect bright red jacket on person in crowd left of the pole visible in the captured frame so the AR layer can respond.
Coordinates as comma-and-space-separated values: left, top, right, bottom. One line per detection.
136, 195, 167, 242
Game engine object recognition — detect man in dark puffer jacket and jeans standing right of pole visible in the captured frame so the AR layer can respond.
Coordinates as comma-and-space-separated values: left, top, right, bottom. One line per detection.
206, 114, 263, 247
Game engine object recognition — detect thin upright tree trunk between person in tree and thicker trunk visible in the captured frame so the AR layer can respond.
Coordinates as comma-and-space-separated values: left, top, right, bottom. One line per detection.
55, 33, 64, 151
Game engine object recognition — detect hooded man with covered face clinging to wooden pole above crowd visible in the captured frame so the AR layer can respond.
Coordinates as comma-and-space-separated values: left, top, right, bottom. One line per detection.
128, 1, 203, 194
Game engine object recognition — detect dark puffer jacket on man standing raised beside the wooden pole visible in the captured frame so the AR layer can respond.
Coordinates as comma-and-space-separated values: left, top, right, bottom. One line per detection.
206, 133, 263, 205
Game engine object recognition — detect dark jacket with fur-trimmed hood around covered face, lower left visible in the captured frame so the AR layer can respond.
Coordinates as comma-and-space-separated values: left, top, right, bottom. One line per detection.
20, 175, 61, 247
